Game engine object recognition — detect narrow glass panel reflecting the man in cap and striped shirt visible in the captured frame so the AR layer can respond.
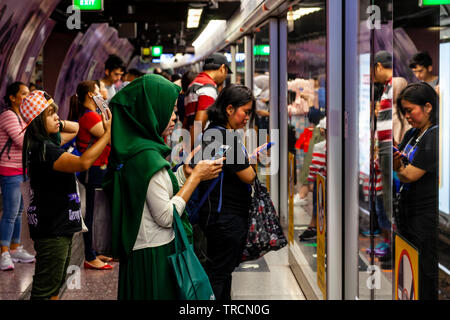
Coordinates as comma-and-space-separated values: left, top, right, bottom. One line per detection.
358, 0, 393, 300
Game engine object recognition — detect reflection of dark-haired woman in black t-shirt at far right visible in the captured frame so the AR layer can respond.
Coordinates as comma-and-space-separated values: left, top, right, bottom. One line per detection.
393, 82, 439, 300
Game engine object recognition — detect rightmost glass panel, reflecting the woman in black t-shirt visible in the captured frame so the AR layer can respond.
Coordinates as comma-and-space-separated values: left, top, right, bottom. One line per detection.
393, 1, 444, 300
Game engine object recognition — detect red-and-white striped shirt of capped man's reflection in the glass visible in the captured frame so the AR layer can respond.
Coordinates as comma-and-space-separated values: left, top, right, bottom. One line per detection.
377, 78, 392, 154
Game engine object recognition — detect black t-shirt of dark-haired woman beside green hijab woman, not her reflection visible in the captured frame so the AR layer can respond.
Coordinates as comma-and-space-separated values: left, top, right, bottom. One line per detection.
199, 125, 252, 218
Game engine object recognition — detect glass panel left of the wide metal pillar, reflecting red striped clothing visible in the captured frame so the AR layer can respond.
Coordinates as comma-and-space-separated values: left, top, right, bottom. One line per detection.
287, 1, 326, 299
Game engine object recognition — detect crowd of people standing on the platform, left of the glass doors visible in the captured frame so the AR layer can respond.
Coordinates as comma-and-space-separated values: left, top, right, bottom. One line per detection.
0, 53, 274, 300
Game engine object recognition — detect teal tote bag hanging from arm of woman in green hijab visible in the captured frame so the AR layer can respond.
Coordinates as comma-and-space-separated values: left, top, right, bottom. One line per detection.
167, 206, 216, 300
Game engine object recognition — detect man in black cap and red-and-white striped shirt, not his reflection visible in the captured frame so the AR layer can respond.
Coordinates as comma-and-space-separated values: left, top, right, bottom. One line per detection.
183, 52, 232, 148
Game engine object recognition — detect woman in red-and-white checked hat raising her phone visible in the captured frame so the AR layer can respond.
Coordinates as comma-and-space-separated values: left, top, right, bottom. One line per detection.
20, 90, 111, 299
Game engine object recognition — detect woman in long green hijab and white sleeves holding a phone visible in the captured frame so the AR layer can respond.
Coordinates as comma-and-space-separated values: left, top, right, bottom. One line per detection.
104, 74, 223, 300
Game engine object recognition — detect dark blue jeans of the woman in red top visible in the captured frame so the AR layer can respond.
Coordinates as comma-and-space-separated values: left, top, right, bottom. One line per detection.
78, 166, 106, 261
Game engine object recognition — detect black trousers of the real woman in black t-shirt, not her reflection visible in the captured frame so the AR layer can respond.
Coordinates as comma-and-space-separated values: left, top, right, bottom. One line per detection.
201, 212, 248, 300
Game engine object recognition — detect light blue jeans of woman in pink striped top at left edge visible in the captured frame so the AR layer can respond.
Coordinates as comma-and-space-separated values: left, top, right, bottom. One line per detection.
0, 174, 23, 247
